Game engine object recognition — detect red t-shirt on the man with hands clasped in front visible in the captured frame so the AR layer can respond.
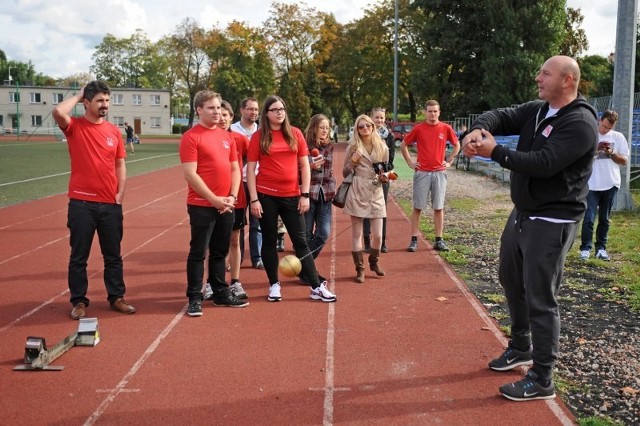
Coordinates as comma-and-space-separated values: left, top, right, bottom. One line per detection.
180, 124, 238, 207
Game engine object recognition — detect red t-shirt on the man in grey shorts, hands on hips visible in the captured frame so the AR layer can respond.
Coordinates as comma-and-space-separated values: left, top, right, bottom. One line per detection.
404, 122, 458, 172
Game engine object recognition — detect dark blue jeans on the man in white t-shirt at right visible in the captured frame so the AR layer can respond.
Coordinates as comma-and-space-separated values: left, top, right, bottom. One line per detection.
580, 186, 618, 251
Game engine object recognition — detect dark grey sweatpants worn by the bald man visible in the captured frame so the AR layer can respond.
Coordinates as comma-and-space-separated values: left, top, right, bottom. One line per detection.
498, 209, 578, 380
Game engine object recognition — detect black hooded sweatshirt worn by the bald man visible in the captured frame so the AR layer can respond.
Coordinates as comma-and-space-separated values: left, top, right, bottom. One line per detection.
471, 95, 598, 221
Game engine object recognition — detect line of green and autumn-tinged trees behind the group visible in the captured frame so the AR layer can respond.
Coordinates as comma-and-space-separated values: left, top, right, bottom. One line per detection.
0, 0, 640, 127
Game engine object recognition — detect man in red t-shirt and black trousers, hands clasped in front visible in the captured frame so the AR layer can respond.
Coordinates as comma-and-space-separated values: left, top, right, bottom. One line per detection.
180, 90, 249, 317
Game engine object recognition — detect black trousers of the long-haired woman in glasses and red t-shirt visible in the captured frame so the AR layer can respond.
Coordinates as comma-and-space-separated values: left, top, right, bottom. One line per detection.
258, 193, 320, 288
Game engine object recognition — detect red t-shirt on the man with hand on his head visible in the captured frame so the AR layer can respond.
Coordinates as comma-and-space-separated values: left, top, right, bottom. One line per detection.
64, 117, 127, 204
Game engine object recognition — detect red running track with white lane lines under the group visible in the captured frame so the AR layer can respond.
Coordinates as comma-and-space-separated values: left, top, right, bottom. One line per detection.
0, 144, 574, 425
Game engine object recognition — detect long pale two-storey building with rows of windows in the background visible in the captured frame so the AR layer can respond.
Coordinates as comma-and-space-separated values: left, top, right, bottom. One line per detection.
0, 81, 171, 136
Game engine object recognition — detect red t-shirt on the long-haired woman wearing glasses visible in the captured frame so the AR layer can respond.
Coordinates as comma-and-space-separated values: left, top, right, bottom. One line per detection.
247, 127, 309, 197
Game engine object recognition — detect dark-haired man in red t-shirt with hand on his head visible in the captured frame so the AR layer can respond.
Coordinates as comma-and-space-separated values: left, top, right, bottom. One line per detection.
52, 81, 136, 319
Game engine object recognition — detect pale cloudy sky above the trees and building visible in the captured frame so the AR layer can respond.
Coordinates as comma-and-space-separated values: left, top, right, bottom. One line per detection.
0, 0, 617, 78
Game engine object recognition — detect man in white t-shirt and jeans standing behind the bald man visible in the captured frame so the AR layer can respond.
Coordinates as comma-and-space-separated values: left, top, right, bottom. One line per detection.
580, 110, 629, 261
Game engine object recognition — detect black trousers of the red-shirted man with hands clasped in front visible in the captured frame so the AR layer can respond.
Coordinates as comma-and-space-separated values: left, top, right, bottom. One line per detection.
187, 205, 234, 300
